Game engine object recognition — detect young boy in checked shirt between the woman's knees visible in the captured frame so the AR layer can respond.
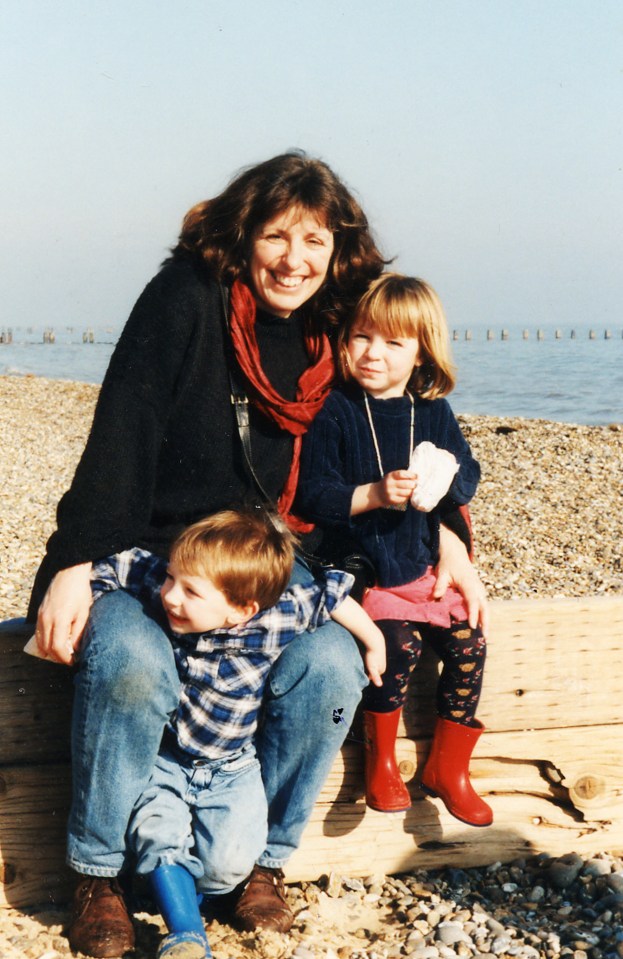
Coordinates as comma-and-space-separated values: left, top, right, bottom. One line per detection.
91, 510, 385, 959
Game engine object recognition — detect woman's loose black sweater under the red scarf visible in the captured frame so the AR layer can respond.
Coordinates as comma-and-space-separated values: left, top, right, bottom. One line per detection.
29, 261, 309, 619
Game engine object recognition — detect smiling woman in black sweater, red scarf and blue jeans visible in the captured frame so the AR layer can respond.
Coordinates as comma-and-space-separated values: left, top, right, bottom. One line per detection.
30, 153, 483, 956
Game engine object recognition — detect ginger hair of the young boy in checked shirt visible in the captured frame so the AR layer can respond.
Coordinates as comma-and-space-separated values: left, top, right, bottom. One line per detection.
170, 509, 296, 609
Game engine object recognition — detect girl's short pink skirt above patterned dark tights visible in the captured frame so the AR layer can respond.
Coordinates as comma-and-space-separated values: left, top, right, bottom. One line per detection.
362, 566, 467, 628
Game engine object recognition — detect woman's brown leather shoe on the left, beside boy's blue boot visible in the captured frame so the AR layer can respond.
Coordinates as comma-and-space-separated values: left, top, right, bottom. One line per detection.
67, 876, 134, 959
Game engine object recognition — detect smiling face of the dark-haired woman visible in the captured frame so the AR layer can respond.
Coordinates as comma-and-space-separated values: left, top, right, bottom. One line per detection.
249, 208, 333, 317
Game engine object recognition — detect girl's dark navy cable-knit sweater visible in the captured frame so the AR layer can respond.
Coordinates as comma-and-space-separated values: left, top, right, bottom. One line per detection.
297, 385, 480, 587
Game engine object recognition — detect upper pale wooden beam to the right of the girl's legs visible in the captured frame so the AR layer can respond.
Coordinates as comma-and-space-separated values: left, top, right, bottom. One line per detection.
403, 596, 623, 736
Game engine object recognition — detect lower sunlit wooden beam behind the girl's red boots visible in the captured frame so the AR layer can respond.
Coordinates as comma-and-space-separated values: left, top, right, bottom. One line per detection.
287, 724, 623, 879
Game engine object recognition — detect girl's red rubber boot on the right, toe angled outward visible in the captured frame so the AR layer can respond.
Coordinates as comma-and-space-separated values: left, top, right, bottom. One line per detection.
421, 719, 493, 826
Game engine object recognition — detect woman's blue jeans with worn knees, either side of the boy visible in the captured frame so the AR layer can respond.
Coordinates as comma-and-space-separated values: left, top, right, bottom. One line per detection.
67, 563, 367, 876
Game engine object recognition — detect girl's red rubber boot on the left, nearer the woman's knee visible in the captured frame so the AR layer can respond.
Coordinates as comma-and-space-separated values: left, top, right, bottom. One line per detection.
363, 709, 411, 812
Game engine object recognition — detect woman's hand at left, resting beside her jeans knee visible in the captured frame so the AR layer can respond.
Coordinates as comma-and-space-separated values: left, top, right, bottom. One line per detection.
35, 563, 92, 666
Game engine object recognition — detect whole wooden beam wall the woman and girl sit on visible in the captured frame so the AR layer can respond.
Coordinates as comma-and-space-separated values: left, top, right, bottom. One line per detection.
0, 596, 623, 906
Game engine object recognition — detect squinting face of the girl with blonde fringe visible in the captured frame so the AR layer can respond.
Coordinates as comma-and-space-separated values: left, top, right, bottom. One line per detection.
346, 320, 419, 400
